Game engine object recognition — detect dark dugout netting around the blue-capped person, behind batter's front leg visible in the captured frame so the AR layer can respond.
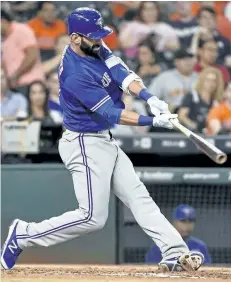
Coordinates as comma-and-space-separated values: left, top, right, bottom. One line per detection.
120, 184, 231, 264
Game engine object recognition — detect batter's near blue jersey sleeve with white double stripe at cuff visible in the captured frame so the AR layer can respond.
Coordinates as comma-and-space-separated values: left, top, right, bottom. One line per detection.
63, 74, 114, 112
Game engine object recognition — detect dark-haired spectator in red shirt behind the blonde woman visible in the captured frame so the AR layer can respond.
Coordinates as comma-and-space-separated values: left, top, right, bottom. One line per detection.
194, 39, 230, 83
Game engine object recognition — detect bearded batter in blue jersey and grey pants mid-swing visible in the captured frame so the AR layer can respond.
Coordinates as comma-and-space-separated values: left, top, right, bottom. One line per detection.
1, 8, 204, 271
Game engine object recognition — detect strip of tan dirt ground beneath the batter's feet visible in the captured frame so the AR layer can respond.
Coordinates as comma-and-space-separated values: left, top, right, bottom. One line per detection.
1, 265, 231, 282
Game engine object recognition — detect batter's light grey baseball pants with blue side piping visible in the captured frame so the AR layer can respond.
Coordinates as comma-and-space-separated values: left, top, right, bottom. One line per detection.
17, 130, 189, 259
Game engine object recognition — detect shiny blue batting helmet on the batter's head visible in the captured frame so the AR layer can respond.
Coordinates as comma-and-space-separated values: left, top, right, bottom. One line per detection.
68, 8, 113, 40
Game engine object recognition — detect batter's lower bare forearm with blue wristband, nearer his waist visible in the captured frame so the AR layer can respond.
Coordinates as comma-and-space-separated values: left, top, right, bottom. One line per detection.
119, 110, 153, 126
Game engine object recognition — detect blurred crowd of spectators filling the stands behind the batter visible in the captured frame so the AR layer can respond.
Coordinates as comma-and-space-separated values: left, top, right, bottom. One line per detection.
1, 1, 231, 135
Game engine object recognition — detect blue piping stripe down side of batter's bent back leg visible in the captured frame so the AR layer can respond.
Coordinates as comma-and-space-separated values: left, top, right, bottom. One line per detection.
16, 133, 93, 240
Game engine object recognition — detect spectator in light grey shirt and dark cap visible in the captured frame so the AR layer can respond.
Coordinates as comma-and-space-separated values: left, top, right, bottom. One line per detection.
149, 49, 197, 112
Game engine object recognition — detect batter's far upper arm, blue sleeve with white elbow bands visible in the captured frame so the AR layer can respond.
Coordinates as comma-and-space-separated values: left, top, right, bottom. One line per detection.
100, 42, 142, 93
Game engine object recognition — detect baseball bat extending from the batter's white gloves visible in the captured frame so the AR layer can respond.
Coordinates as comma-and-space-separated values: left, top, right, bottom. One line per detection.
171, 119, 227, 164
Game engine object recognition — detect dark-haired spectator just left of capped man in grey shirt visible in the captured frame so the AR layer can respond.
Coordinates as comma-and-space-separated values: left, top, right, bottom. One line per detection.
135, 41, 167, 87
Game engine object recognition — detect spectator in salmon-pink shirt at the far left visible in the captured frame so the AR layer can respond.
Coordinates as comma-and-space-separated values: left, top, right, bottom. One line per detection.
1, 10, 44, 94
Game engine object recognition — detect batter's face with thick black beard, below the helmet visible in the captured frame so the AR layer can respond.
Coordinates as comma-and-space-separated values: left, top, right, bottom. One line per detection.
79, 37, 102, 58
